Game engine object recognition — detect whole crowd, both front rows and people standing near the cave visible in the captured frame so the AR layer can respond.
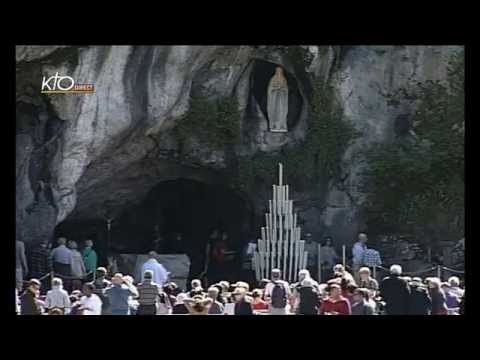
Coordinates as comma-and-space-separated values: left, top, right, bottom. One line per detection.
16, 234, 465, 315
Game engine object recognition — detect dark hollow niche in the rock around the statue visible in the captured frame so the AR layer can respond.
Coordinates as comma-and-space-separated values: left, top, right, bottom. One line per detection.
249, 59, 303, 129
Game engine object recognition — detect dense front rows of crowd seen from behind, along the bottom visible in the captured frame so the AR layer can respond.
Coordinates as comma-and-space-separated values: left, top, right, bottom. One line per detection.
17, 264, 465, 315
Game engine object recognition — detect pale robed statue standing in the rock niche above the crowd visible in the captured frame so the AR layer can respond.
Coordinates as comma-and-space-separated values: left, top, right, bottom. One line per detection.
267, 67, 288, 132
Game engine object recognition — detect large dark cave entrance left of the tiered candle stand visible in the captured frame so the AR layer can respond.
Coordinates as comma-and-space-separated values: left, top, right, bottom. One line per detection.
56, 179, 255, 280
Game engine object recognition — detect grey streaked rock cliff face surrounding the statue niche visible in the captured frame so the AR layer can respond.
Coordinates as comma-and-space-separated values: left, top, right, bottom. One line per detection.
16, 46, 457, 248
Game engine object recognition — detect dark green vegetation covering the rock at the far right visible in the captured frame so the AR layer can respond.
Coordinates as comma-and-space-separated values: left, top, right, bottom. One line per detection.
364, 52, 465, 244
